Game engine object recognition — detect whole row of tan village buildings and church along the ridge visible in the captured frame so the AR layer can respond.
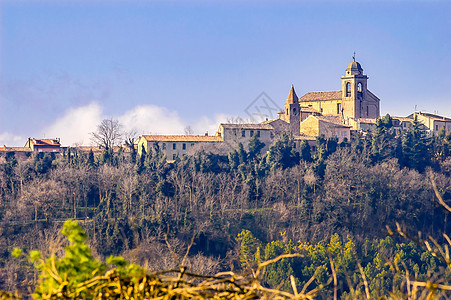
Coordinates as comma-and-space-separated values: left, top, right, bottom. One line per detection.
0, 59, 451, 160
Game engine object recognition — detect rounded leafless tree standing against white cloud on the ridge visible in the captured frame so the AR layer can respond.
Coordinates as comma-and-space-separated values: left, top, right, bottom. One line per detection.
91, 118, 123, 150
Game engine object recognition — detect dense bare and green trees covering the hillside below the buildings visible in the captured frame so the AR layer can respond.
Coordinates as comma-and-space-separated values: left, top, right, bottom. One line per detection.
0, 116, 451, 297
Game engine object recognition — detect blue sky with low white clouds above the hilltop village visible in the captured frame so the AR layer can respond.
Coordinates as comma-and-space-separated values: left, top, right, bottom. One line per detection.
0, 0, 451, 145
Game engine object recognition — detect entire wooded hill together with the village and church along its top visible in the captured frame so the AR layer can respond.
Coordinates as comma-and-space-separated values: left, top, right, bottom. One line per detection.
0, 60, 451, 299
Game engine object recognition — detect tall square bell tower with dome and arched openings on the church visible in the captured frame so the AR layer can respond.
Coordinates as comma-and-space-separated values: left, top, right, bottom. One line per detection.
341, 54, 373, 119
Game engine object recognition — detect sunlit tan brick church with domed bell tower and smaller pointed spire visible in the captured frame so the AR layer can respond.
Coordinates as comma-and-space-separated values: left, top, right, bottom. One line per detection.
251, 58, 380, 141
